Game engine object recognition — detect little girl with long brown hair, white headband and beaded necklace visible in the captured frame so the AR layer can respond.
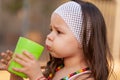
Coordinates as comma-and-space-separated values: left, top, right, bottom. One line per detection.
2, 0, 112, 80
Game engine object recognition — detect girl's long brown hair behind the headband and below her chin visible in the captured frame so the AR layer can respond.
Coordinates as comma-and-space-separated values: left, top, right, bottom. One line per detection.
45, 0, 112, 80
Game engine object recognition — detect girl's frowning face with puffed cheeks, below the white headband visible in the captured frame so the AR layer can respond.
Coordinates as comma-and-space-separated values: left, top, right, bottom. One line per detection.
46, 13, 80, 58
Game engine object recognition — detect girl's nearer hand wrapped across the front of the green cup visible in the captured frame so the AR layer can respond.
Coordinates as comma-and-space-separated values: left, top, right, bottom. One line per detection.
13, 51, 43, 80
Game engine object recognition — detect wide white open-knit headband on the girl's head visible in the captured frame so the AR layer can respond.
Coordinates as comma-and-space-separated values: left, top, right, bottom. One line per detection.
54, 1, 83, 43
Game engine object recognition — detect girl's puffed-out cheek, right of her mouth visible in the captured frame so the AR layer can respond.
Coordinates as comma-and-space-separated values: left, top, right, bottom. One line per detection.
54, 40, 77, 57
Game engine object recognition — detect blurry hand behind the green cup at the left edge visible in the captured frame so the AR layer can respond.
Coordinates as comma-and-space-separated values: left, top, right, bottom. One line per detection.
0, 50, 13, 70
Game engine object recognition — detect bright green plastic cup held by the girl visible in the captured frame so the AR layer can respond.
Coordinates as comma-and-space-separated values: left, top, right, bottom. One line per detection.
8, 37, 44, 78
